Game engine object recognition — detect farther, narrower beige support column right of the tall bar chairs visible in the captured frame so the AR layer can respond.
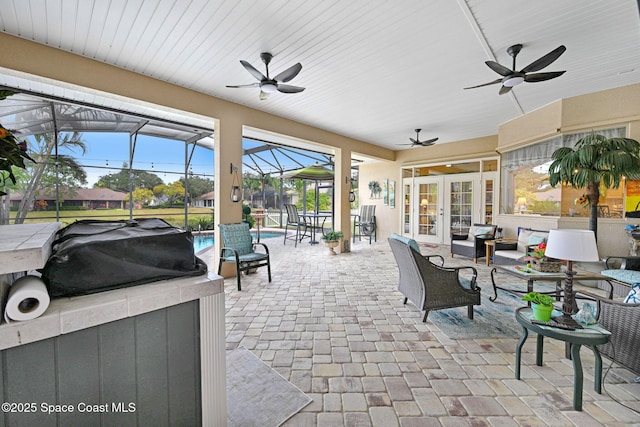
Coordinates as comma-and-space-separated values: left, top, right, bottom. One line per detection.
334, 148, 351, 252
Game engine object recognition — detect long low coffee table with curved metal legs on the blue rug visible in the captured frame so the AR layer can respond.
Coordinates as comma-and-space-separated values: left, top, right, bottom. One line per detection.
489, 265, 613, 302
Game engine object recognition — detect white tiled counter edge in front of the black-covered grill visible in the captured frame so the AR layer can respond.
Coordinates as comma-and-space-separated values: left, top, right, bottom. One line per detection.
0, 272, 224, 350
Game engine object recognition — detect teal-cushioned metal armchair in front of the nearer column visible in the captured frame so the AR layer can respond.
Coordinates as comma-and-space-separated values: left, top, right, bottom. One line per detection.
218, 222, 271, 291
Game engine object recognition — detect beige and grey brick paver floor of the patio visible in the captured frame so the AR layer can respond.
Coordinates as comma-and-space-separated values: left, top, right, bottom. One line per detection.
202, 238, 640, 427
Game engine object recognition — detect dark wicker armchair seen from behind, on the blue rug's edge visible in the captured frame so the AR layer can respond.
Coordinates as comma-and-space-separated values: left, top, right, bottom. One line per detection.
389, 234, 480, 322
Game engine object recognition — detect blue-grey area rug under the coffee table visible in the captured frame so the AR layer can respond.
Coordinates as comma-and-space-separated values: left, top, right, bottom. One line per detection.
427, 282, 554, 339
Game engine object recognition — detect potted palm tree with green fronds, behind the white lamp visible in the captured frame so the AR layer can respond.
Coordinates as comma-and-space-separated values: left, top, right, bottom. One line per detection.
549, 133, 640, 236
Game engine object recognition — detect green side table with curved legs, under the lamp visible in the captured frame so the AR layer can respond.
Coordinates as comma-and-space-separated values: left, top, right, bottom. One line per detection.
515, 307, 611, 411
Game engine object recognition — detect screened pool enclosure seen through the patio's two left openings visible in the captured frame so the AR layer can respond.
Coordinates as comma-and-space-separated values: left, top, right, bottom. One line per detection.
0, 78, 356, 230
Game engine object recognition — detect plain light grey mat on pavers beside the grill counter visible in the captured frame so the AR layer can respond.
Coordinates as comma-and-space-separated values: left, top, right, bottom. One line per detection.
227, 347, 312, 427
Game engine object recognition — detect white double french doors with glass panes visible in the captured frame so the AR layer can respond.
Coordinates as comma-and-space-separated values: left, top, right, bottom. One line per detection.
410, 173, 482, 243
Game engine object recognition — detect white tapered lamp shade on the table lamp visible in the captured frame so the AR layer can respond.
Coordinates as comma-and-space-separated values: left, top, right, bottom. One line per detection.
544, 230, 599, 262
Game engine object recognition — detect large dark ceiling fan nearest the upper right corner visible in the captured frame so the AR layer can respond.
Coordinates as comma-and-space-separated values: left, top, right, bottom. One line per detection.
465, 44, 567, 95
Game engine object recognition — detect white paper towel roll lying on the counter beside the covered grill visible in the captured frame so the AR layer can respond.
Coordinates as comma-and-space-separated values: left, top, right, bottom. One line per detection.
4, 276, 50, 322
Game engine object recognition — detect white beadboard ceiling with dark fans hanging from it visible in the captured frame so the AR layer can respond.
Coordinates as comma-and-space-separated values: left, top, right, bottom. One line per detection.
0, 0, 640, 149
